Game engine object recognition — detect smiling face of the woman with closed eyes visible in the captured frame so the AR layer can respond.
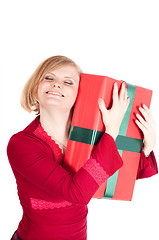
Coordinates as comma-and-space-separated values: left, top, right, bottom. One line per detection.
37, 65, 80, 111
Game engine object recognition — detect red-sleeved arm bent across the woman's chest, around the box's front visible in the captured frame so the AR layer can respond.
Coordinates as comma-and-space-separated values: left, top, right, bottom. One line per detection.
7, 132, 123, 205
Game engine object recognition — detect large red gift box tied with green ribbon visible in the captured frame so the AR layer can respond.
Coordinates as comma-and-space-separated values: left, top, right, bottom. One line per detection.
64, 73, 152, 200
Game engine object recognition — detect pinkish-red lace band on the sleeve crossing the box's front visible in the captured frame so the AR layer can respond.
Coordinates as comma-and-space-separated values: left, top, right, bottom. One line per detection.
83, 158, 109, 186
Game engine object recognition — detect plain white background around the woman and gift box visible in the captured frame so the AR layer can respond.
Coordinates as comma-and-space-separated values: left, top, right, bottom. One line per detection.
0, 0, 159, 240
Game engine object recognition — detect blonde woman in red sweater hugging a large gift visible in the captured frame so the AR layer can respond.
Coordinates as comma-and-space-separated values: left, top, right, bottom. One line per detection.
7, 56, 157, 240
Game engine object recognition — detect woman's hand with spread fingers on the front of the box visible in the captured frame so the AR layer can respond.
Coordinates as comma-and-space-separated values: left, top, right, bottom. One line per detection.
98, 83, 130, 140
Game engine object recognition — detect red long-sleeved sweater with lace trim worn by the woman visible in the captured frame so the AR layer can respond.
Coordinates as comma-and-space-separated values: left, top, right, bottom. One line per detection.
7, 117, 157, 240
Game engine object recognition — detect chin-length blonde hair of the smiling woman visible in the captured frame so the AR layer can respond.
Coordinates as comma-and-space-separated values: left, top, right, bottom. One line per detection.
20, 55, 82, 115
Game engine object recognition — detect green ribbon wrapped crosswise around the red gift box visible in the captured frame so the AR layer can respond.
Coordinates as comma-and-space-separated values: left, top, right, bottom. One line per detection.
69, 84, 143, 198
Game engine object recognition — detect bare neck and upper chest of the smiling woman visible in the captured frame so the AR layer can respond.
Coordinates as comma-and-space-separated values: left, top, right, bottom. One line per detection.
40, 108, 71, 145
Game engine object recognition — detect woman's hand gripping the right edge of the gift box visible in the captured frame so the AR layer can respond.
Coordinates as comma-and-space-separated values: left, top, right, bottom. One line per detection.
136, 104, 156, 157
